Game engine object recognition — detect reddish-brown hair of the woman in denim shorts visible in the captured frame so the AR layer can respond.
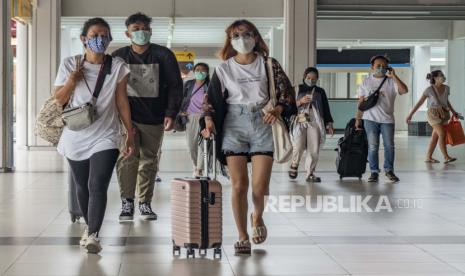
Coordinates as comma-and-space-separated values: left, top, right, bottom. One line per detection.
218, 19, 270, 60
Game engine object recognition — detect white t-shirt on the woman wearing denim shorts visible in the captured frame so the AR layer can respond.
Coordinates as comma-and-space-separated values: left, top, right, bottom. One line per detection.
216, 55, 268, 105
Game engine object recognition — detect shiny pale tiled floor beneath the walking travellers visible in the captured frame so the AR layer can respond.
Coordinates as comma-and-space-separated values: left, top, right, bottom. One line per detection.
0, 133, 465, 276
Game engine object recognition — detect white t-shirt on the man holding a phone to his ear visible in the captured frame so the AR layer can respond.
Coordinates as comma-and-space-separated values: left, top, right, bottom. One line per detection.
358, 74, 399, 124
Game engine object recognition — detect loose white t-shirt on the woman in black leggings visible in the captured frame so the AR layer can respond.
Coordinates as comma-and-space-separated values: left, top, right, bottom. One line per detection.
55, 57, 129, 161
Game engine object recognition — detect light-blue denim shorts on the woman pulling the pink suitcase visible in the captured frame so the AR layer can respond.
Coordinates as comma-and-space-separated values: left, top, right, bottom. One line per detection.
222, 104, 274, 157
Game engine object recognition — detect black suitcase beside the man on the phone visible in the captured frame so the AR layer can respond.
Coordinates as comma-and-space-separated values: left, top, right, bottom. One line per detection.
336, 119, 368, 179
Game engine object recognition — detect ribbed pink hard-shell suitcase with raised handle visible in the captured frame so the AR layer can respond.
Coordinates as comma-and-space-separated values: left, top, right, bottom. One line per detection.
171, 136, 223, 259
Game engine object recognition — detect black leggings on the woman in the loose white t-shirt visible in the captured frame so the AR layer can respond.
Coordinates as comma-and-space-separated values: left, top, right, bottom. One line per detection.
68, 149, 119, 235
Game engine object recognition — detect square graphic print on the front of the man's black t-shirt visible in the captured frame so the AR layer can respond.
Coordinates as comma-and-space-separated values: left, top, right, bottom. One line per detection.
128, 63, 160, 98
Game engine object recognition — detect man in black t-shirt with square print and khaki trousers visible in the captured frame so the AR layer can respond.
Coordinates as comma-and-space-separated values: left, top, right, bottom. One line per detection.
113, 13, 183, 221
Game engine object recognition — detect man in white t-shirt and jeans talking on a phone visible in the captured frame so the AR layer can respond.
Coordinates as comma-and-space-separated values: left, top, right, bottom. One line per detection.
356, 56, 408, 182
